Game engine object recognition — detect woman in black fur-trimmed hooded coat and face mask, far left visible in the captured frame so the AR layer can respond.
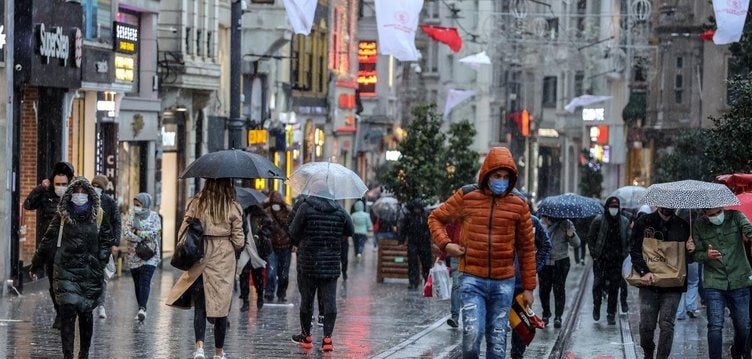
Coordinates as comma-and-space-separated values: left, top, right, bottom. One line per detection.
30, 177, 112, 359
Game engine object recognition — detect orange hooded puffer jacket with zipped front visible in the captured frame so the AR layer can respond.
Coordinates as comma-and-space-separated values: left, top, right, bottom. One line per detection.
428, 147, 536, 290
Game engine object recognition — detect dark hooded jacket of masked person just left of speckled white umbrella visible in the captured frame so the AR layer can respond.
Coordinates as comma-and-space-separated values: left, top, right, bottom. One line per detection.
587, 196, 630, 266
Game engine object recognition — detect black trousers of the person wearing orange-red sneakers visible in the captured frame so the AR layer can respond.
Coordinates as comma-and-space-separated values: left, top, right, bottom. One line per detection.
298, 273, 337, 337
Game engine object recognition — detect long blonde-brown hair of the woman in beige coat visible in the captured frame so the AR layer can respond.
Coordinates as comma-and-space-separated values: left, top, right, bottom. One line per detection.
197, 178, 235, 224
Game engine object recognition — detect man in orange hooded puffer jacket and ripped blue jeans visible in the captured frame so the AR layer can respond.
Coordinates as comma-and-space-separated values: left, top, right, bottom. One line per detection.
428, 147, 536, 359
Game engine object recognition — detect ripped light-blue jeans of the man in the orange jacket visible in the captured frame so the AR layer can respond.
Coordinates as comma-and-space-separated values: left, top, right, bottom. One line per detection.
460, 273, 514, 359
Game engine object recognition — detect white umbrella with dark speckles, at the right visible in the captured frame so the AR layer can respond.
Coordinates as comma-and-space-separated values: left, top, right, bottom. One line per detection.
641, 180, 739, 208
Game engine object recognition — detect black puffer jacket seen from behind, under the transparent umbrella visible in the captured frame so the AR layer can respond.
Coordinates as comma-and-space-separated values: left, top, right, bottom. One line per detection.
290, 197, 353, 278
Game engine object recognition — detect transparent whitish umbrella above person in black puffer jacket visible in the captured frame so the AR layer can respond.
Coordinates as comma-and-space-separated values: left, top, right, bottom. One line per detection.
287, 162, 368, 200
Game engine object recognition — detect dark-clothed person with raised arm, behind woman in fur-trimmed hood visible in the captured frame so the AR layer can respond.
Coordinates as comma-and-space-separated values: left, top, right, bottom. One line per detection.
24, 162, 74, 329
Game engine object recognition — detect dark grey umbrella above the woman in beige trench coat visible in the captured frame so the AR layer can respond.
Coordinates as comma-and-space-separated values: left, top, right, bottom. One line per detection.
180, 150, 285, 179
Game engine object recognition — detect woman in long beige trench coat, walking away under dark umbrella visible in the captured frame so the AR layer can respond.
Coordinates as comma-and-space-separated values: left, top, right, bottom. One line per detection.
167, 178, 244, 359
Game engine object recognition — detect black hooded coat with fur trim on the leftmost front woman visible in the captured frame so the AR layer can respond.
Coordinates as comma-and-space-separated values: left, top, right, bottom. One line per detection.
31, 177, 112, 312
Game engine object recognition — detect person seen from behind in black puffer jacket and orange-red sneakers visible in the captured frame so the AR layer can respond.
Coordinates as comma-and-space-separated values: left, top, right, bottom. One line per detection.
289, 193, 353, 351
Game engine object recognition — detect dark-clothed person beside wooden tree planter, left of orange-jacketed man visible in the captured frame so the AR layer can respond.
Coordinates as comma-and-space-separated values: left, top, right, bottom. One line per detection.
399, 199, 431, 289
